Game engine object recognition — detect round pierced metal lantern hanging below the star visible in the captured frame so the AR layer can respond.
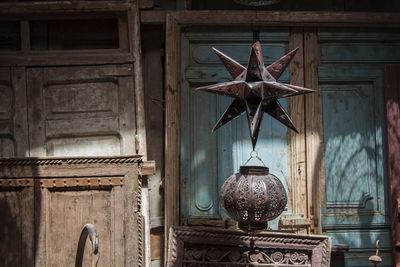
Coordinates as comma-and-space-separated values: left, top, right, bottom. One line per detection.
219, 166, 287, 231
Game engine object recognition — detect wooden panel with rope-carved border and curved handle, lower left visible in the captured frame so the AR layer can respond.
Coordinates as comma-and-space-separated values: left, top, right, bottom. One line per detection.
0, 156, 143, 266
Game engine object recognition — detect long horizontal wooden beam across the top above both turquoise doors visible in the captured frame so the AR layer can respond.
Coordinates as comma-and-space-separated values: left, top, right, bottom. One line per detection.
141, 10, 400, 27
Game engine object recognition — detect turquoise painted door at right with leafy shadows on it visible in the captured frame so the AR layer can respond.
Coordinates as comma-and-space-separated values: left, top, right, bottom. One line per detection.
318, 29, 400, 267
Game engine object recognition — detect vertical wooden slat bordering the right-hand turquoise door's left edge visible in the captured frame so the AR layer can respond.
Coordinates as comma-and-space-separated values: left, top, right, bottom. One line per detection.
304, 28, 325, 233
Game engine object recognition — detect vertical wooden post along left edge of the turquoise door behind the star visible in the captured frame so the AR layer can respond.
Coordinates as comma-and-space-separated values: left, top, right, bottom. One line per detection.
164, 12, 181, 255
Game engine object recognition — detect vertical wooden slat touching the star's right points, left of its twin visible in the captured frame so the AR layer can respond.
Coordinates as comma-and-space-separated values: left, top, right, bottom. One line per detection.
287, 28, 309, 233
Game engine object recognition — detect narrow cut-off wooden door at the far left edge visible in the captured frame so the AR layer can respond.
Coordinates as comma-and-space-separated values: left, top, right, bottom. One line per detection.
0, 67, 29, 158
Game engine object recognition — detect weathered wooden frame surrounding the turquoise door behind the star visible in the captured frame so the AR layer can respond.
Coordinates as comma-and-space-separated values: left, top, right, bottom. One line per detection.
164, 11, 400, 245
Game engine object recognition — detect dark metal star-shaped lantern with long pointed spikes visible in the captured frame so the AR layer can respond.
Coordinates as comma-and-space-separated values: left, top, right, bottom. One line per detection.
196, 41, 315, 149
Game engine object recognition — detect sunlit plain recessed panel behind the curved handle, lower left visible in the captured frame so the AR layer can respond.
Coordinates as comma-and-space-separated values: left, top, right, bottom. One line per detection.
47, 190, 112, 266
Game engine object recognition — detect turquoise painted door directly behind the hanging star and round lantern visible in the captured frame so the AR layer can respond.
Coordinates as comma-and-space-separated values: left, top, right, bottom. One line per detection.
180, 28, 289, 229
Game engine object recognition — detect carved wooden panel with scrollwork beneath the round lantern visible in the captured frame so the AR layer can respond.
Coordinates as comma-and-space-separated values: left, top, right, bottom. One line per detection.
167, 227, 331, 267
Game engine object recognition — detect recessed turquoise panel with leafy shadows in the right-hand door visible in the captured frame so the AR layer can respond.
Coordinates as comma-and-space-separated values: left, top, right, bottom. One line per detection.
322, 84, 377, 210
